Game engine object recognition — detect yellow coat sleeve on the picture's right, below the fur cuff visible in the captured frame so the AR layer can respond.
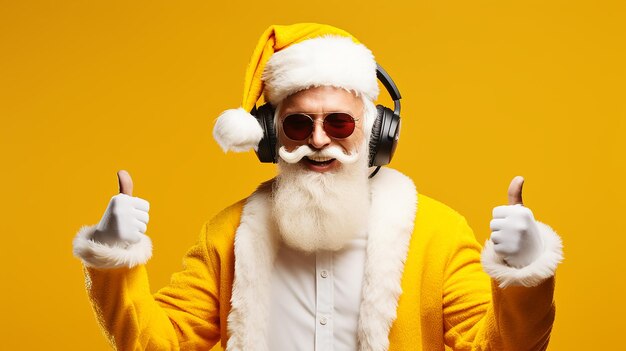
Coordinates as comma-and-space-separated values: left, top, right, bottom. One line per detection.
443, 218, 555, 350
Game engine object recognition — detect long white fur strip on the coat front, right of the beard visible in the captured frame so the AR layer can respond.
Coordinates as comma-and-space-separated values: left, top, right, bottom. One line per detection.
358, 168, 418, 351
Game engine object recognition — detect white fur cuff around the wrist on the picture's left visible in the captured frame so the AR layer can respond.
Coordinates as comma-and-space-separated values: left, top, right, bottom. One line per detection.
74, 225, 152, 268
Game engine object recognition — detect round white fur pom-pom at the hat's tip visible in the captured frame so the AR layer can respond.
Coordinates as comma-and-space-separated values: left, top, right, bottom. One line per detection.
213, 107, 263, 152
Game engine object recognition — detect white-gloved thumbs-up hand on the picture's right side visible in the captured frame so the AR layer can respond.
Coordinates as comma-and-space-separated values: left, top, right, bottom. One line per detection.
490, 176, 544, 268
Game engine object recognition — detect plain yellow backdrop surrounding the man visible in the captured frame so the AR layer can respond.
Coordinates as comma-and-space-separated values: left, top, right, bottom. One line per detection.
0, 0, 626, 350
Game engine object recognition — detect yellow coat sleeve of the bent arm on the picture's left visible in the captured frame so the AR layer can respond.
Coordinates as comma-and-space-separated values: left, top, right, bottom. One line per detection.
85, 204, 241, 351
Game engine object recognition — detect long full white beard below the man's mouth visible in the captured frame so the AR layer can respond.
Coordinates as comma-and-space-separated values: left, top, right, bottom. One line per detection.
272, 143, 370, 253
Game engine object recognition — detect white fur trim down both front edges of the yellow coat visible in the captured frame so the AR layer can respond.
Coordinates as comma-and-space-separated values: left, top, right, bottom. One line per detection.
226, 168, 417, 351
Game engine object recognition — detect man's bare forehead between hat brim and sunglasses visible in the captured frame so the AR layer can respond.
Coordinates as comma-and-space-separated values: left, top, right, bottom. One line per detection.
281, 86, 362, 114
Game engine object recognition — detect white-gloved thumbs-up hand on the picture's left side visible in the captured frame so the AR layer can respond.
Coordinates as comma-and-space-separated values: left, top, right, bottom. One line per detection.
93, 171, 150, 246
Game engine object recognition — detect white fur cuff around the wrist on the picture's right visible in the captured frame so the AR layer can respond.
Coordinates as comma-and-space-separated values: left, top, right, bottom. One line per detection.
481, 221, 563, 288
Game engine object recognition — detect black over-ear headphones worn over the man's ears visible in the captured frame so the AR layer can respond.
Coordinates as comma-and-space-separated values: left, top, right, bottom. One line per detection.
250, 64, 402, 170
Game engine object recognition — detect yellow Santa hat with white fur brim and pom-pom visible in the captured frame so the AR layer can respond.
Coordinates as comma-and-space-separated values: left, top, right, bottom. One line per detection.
213, 23, 379, 152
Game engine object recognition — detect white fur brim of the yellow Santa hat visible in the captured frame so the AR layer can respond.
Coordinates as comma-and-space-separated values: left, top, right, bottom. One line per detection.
262, 36, 379, 106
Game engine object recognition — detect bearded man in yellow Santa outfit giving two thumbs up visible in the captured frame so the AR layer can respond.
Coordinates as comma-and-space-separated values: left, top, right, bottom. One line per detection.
74, 24, 562, 350
